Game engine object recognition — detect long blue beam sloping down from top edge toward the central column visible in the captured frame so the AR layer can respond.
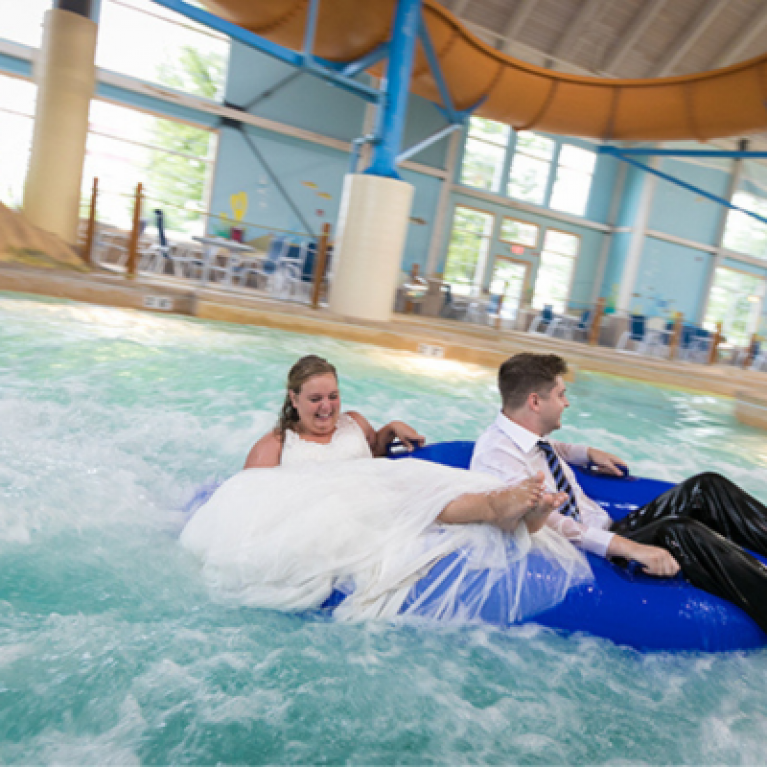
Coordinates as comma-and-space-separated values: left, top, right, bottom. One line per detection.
153, 0, 381, 104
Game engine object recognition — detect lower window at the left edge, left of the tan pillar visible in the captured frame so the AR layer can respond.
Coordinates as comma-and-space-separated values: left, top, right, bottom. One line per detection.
0, 75, 37, 207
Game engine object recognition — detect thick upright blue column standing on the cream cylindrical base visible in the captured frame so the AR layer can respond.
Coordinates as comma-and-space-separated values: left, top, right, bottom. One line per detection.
365, 0, 421, 179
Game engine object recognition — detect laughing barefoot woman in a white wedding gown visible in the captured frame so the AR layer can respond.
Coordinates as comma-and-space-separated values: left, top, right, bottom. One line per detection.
181, 355, 591, 623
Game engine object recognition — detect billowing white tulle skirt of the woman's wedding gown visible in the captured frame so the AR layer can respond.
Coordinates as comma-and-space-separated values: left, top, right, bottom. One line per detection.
181, 438, 590, 623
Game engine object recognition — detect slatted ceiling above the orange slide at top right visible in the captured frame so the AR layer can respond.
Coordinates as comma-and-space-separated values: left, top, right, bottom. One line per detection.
438, 0, 767, 78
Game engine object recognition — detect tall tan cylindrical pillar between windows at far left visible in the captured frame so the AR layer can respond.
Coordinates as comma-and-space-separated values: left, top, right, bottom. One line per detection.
24, 0, 98, 244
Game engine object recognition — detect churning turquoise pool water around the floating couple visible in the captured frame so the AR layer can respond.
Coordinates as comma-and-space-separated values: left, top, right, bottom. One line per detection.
0, 295, 767, 765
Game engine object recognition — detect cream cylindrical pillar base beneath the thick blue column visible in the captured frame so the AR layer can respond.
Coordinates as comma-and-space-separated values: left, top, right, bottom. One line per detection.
330, 174, 413, 322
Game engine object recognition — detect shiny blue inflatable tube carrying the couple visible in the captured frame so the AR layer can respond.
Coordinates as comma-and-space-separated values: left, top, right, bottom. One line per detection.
340, 442, 767, 652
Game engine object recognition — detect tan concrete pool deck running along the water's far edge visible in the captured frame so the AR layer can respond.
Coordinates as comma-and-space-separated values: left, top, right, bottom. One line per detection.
0, 264, 767, 428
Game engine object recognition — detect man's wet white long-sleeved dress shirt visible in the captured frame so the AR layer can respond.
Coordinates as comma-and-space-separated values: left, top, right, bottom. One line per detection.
470, 413, 614, 557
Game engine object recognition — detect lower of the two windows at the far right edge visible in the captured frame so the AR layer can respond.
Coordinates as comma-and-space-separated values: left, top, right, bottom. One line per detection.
703, 267, 765, 346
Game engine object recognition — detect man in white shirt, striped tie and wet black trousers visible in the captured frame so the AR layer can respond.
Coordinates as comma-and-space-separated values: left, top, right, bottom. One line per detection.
471, 353, 767, 632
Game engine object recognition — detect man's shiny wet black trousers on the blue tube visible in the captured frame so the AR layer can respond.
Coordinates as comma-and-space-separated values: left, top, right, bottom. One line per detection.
610, 472, 767, 633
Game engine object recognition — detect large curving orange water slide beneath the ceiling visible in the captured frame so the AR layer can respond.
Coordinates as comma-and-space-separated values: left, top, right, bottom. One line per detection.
205, 0, 767, 141
